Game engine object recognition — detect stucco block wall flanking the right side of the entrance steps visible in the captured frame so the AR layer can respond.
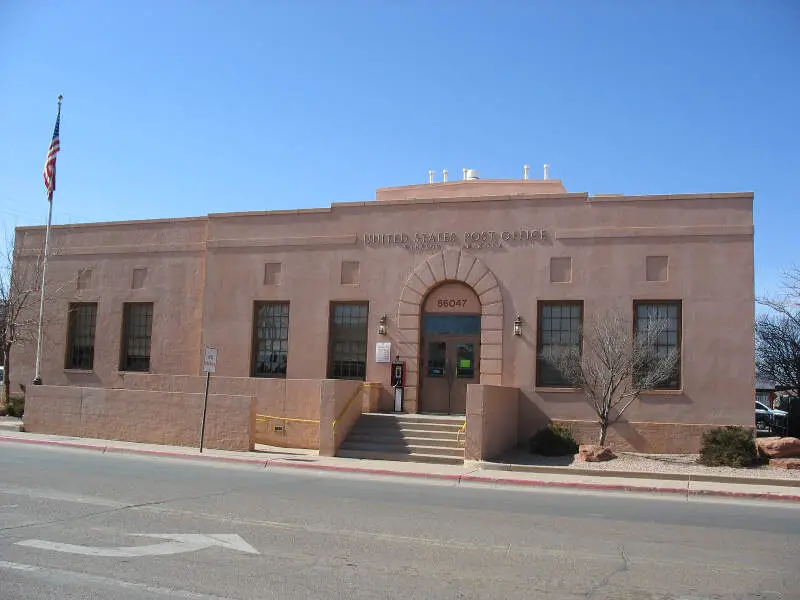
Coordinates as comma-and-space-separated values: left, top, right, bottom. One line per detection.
464, 384, 519, 460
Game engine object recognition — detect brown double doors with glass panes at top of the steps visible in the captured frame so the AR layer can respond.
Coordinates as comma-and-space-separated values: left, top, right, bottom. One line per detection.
419, 334, 480, 415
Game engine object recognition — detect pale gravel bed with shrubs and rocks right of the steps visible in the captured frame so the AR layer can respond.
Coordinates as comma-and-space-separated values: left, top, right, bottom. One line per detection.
497, 451, 800, 482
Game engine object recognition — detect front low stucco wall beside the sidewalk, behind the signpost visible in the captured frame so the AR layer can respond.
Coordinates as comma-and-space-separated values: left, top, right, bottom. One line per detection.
23, 386, 255, 451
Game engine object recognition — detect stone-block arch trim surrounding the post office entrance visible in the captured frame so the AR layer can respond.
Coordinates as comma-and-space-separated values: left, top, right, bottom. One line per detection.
397, 248, 504, 413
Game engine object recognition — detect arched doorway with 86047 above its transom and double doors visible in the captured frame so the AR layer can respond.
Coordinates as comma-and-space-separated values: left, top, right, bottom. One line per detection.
419, 282, 481, 415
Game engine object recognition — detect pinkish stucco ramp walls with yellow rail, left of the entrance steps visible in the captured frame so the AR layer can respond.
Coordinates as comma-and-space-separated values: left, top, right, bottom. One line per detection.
24, 373, 381, 456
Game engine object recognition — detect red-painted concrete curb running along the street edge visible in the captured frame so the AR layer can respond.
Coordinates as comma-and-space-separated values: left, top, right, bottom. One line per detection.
0, 435, 800, 502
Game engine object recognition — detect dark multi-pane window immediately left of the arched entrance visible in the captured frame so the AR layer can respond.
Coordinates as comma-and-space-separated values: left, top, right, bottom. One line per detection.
328, 302, 369, 380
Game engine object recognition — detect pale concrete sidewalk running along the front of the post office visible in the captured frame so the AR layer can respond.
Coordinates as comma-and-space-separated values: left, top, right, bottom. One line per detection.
0, 429, 800, 502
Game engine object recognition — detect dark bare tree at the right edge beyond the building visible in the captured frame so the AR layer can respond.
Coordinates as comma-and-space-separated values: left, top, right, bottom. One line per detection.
756, 266, 800, 390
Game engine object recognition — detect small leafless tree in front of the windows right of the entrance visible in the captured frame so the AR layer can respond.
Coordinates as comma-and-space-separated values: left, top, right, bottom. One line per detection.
542, 310, 678, 446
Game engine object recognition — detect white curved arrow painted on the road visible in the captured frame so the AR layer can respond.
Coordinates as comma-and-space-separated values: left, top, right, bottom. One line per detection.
16, 533, 259, 558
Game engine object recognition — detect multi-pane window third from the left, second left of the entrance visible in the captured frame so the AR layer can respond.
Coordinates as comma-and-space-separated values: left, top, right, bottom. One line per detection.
252, 302, 289, 377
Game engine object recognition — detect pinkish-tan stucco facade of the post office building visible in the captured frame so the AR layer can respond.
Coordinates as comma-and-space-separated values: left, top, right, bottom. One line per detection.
12, 180, 754, 452
